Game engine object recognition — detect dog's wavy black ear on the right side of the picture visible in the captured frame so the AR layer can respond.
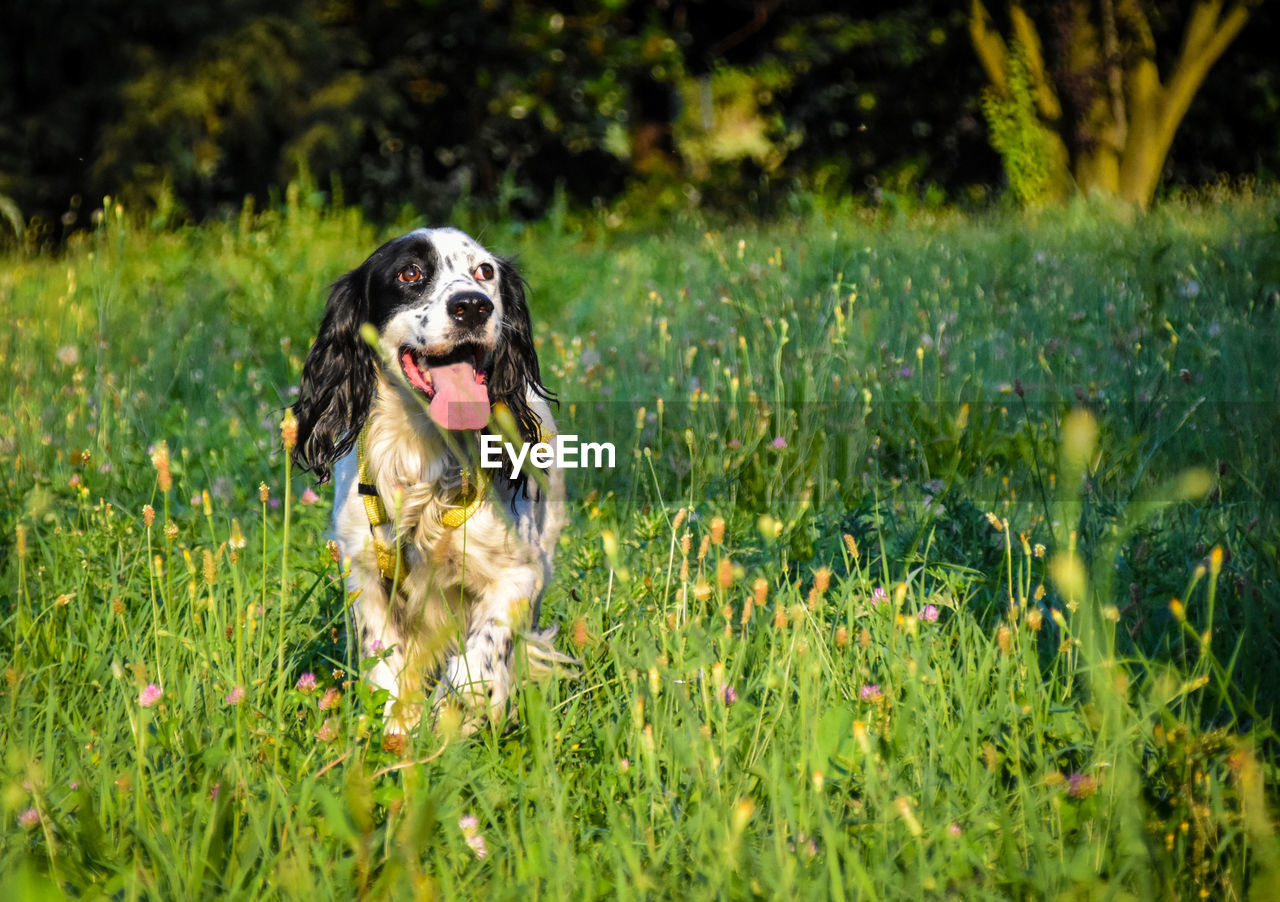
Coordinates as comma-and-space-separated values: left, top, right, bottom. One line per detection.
489, 254, 556, 489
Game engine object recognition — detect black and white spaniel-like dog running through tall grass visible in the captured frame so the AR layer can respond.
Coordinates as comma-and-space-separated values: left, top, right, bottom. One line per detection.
292, 228, 575, 733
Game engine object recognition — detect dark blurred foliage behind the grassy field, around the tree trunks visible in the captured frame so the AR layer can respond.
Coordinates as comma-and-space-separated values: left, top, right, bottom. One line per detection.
0, 0, 1280, 244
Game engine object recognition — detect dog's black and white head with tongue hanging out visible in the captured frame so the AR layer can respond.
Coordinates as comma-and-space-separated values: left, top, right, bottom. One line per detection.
293, 229, 550, 481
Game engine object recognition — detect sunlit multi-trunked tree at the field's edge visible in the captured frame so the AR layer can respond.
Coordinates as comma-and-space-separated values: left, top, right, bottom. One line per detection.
969, 0, 1261, 206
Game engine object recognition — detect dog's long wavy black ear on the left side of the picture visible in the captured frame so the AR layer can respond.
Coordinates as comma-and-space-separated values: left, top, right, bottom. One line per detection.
293, 266, 378, 482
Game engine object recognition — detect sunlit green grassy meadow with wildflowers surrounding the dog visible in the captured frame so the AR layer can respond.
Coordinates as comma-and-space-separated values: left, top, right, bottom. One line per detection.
0, 193, 1280, 901
